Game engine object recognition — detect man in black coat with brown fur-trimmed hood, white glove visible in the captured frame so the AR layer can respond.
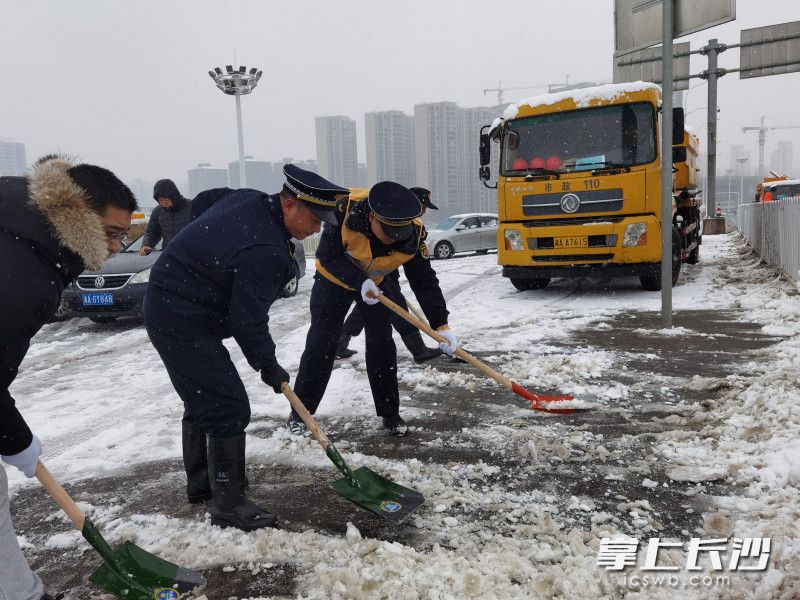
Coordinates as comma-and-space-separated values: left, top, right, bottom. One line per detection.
0, 155, 137, 600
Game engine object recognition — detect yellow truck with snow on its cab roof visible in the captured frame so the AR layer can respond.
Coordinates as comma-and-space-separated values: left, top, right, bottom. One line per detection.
480, 82, 700, 290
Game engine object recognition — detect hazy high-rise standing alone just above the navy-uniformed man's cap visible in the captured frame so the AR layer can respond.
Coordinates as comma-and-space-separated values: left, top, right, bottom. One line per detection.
315, 116, 358, 187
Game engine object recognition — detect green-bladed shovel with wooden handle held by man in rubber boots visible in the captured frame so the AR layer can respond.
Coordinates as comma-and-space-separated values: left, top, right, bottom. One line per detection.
281, 383, 425, 525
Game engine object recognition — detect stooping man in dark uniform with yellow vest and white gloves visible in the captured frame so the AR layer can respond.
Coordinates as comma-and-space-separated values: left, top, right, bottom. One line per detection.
287, 181, 458, 435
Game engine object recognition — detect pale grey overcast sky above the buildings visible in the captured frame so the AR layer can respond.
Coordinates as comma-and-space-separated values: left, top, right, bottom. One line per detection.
0, 0, 800, 192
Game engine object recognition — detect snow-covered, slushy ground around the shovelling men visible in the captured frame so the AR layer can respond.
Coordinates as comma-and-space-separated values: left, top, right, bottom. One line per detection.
9, 235, 800, 599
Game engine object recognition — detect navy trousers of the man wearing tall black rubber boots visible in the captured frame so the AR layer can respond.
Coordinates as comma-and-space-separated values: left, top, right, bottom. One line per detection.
144, 286, 250, 437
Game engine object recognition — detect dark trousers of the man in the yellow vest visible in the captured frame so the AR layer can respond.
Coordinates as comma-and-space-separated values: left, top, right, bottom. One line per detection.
295, 274, 400, 417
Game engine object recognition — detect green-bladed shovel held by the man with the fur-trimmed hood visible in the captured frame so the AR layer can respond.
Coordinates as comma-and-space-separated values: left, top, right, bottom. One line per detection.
36, 462, 206, 600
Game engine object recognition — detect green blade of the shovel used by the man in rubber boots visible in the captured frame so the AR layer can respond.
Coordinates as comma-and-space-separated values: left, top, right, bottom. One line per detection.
331, 467, 425, 524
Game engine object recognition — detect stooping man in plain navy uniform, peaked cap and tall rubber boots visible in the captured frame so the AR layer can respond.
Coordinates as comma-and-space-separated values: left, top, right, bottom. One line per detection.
144, 164, 347, 531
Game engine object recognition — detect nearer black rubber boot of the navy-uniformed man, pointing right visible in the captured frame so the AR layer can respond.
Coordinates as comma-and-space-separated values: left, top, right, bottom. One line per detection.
208, 433, 277, 531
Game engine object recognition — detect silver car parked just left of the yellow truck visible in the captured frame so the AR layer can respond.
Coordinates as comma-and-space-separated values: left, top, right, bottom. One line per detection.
425, 213, 497, 258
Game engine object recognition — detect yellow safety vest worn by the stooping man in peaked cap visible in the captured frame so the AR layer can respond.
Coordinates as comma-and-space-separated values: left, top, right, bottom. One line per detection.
316, 189, 423, 291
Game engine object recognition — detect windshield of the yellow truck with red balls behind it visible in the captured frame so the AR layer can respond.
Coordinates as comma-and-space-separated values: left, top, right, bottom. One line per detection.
501, 102, 656, 176
